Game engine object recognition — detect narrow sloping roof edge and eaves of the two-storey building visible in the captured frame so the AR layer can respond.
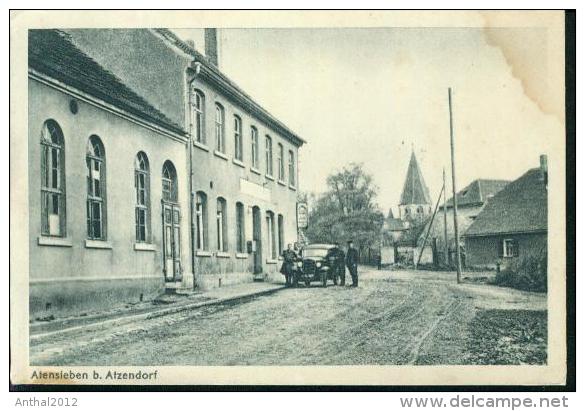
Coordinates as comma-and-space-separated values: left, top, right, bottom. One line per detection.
155, 28, 306, 146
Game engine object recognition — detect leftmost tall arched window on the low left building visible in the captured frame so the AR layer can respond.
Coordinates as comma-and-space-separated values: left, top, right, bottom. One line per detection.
41, 120, 67, 237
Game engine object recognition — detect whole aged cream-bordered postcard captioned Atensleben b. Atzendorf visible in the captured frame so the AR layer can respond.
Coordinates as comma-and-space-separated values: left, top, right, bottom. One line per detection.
10, 11, 567, 386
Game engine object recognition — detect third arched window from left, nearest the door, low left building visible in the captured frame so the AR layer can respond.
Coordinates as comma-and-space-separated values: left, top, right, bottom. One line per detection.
134, 151, 151, 243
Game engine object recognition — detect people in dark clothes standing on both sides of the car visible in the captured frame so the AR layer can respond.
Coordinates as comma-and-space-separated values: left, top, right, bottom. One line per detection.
281, 240, 359, 287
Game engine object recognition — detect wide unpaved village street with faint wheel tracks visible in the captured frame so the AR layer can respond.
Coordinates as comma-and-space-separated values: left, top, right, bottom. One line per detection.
30, 270, 546, 366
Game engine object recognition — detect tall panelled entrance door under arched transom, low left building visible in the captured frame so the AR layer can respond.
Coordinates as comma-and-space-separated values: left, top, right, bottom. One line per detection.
162, 201, 182, 282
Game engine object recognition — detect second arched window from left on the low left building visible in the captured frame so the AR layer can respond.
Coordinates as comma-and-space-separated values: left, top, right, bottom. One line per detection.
86, 135, 107, 240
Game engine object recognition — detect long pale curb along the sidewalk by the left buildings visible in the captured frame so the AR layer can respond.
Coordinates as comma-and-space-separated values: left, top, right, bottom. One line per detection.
29, 285, 285, 342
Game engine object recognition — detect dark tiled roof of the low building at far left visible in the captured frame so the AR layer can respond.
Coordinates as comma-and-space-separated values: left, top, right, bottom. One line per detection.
28, 29, 185, 135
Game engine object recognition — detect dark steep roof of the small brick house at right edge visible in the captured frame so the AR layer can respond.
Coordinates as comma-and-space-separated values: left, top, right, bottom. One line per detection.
465, 168, 548, 237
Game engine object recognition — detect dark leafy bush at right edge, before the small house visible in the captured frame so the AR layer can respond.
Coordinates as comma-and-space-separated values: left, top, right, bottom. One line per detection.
494, 251, 548, 292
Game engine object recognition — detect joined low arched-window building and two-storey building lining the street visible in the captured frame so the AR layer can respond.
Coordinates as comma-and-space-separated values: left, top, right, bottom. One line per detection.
29, 30, 303, 315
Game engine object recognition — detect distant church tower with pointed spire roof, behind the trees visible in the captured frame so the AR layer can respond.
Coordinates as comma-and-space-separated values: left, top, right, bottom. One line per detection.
398, 150, 431, 221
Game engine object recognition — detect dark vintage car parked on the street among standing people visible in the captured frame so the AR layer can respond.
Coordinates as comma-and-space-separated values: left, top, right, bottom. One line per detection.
293, 244, 343, 287
